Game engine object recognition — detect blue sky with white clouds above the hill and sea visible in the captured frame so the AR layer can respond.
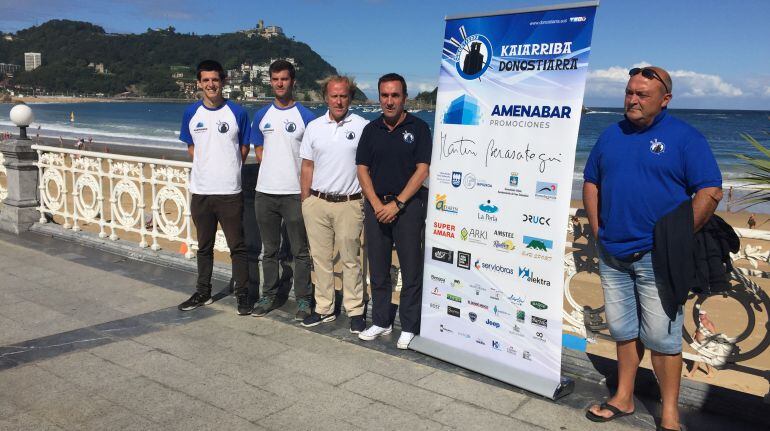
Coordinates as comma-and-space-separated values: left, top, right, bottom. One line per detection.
0, 0, 770, 110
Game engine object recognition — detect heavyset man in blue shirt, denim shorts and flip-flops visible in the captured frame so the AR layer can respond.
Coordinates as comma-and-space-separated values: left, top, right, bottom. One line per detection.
583, 67, 722, 430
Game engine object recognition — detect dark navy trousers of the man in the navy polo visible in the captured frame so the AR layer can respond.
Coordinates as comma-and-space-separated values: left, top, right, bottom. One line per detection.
364, 188, 428, 334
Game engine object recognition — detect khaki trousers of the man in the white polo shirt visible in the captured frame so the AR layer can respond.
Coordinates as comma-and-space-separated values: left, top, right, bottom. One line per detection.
302, 196, 364, 317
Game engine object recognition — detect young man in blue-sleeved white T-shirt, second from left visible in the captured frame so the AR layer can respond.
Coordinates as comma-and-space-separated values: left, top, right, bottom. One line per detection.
250, 60, 315, 321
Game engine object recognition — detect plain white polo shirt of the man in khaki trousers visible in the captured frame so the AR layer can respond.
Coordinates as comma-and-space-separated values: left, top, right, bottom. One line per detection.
299, 111, 369, 195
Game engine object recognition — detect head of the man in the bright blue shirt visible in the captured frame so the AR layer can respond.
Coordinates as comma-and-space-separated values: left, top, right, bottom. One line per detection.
623, 73, 671, 128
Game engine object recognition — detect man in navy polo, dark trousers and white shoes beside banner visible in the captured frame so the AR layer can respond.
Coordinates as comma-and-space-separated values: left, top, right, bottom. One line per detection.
356, 73, 432, 349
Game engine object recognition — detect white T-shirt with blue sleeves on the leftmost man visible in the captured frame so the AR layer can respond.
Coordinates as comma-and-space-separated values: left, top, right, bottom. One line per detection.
179, 100, 249, 195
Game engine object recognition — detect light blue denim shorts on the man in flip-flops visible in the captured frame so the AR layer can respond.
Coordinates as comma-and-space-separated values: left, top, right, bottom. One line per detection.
598, 245, 684, 355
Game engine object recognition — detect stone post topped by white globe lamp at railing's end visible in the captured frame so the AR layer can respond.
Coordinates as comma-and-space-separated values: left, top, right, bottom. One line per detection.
0, 105, 40, 235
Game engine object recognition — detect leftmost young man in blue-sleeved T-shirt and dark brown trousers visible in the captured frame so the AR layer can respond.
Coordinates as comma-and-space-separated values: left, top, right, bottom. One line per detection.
179, 60, 251, 315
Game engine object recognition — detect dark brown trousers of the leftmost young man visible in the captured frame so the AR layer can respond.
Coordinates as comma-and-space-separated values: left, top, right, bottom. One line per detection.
190, 193, 249, 295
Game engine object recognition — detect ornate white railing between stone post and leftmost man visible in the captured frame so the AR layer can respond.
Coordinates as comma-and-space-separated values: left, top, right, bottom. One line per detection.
32, 145, 229, 259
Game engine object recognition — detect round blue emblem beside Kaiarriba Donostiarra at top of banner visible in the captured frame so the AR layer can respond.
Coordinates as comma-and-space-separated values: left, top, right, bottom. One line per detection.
444, 26, 493, 80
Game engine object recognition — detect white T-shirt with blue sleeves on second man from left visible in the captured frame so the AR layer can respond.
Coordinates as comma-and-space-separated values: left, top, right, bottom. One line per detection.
250, 103, 315, 195
